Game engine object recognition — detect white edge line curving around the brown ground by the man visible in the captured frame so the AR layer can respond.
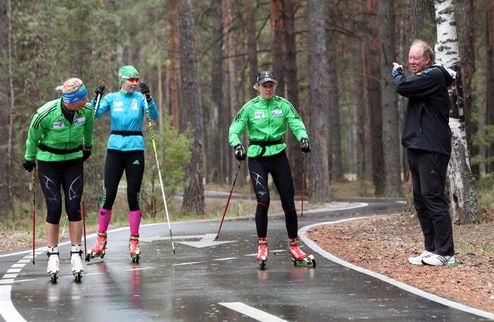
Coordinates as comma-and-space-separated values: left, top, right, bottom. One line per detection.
299, 217, 494, 320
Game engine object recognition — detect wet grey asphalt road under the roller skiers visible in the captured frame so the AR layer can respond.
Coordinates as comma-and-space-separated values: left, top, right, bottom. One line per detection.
0, 201, 487, 321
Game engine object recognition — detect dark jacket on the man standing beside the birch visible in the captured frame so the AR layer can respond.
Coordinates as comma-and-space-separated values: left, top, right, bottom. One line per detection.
392, 65, 453, 155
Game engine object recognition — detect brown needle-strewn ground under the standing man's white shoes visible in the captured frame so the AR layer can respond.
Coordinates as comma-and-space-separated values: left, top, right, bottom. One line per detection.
309, 214, 494, 313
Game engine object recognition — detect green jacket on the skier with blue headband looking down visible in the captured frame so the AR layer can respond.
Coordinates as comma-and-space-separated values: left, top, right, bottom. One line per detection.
24, 99, 94, 161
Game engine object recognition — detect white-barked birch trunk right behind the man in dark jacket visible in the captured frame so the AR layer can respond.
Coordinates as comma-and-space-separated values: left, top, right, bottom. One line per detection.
434, 0, 480, 224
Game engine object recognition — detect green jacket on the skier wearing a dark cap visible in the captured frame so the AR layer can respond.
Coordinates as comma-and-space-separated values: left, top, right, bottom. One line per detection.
228, 96, 309, 158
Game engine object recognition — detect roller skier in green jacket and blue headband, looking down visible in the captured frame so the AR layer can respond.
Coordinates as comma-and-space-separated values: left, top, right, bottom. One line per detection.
23, 78, 94, 282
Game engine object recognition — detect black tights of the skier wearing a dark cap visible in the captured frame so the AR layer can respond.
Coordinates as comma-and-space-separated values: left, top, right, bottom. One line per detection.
249, 151, 298, 238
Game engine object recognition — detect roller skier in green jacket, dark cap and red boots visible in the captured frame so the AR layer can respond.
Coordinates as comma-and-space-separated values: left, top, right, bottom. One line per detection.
228, 71, 315, 269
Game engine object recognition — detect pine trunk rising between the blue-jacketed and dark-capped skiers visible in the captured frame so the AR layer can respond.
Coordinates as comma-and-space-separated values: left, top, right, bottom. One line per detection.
179, 0, 205, 215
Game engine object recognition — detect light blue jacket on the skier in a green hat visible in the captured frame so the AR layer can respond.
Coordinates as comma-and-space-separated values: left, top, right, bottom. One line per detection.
93, 90, 159, 151
